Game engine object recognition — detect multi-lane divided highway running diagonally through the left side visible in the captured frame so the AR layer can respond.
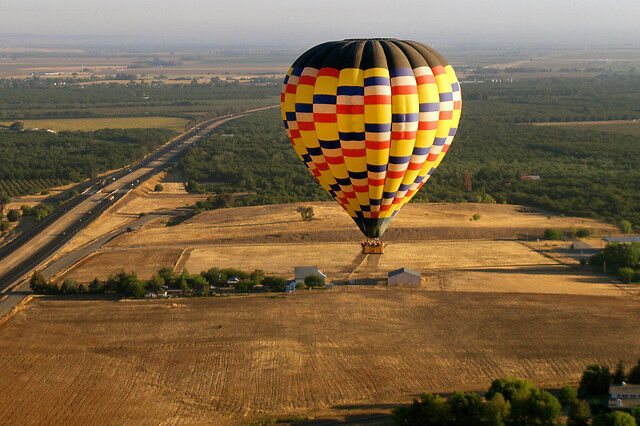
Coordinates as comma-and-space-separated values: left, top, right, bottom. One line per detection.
0, 107, 273, 316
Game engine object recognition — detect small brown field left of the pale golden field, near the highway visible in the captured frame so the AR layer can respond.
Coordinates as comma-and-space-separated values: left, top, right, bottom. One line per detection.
64, 248, 182, 283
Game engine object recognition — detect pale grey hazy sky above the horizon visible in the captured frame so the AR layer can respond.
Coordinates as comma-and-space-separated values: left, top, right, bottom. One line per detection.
0, 0, 640, 47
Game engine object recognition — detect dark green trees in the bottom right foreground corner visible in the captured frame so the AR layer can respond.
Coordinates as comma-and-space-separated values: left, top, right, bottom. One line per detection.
393, 360, 640, 426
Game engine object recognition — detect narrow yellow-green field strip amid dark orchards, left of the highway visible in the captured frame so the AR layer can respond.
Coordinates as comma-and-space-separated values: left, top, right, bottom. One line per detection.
0, 117, 188, 132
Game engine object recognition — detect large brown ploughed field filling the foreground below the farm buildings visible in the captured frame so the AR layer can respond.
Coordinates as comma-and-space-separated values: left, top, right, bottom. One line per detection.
0, 287, 640, 424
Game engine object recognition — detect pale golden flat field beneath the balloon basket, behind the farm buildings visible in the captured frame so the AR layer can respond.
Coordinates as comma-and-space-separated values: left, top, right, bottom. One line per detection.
181, 241, 555, 279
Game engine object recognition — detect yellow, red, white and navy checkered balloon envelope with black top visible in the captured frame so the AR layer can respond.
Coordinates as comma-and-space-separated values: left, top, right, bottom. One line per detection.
281, 38, 461, 246
